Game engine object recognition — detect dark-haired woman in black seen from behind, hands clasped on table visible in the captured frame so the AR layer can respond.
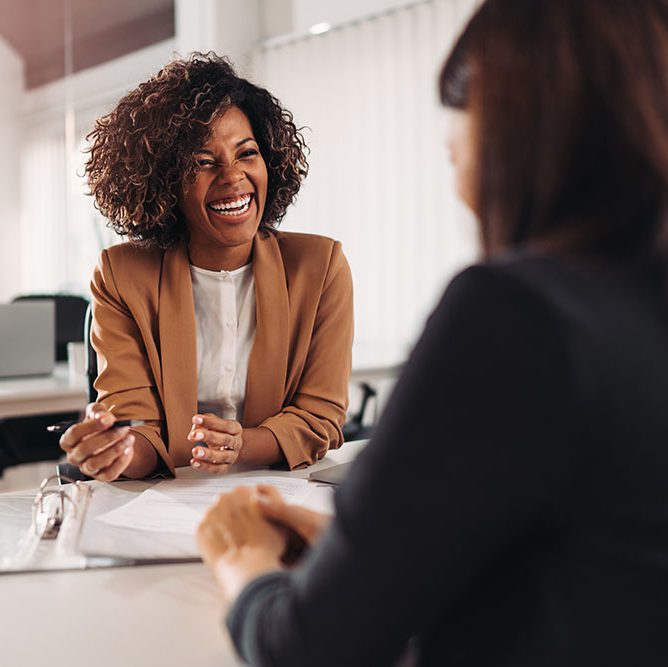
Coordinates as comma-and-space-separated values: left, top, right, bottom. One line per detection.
199, 0, 668, 667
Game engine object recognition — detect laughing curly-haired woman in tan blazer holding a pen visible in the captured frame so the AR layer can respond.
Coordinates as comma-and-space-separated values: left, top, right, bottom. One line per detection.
61, 53, 353, 481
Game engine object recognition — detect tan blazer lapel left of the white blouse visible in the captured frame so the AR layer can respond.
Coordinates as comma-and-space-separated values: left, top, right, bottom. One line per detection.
158, 243, 197, 466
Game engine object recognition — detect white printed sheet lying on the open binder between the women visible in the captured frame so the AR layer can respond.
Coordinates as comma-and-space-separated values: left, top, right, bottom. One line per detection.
97, 476, 313, 535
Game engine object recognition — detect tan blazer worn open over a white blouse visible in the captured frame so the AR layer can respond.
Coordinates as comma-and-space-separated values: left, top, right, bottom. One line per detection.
91, 232, 353, 474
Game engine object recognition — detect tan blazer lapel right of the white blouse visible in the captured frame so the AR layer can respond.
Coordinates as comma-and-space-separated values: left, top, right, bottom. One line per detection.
243, 233, 290, 427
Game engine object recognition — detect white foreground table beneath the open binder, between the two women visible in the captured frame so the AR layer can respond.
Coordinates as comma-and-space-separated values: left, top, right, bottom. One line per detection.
0, 443, 363, 667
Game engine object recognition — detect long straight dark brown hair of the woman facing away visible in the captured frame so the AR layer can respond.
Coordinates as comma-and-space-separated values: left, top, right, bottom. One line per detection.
439, 0, 668, 263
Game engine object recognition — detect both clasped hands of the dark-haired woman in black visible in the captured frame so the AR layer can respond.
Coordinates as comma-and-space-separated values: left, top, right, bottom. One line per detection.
197, 485, 330, 604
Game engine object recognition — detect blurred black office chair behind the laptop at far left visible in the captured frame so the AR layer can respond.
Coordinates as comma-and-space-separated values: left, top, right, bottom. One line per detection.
0, 294, 88, 474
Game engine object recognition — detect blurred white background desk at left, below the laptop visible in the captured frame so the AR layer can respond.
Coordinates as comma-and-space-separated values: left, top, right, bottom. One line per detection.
0, 363, 87, 419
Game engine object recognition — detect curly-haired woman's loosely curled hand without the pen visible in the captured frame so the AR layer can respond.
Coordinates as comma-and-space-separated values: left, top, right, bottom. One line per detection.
188, 413, 244, 474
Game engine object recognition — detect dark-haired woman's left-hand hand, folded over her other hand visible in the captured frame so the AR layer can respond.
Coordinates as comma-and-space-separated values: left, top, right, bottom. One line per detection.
197, 487, 285, 603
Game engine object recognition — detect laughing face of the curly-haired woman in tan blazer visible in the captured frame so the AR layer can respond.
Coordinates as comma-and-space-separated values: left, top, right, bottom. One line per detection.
179, 107, 268, 253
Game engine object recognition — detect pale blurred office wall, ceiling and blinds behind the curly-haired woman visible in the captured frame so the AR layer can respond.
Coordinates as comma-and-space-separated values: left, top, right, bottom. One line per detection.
0, 0, 478, 366
